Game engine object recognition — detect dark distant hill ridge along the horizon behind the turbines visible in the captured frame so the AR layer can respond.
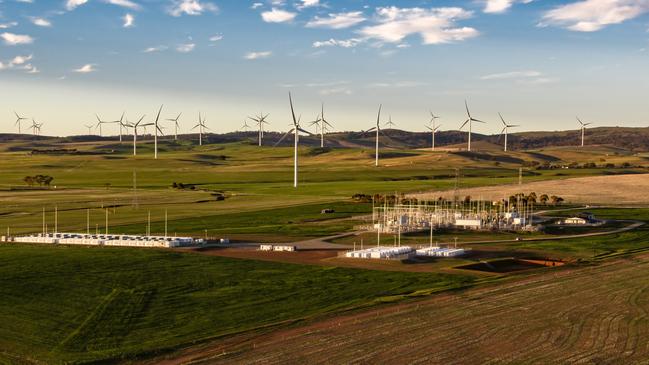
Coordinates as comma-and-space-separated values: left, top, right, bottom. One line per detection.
0, 127, 649, 151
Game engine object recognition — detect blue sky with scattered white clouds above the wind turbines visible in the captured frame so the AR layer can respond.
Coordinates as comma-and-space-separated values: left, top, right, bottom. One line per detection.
0, 0, 649, 135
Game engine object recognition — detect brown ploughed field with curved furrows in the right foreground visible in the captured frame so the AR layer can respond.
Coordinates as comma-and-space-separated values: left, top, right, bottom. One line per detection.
156, 255, 649, 364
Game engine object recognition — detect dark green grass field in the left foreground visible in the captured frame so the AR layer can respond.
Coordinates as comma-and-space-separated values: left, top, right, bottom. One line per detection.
0, 245, 472, 363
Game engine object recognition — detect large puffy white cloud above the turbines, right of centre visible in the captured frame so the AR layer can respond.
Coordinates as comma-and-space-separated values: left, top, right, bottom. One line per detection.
360, 6, 479, 44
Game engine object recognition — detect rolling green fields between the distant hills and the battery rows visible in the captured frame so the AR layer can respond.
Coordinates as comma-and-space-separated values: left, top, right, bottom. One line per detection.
0, 141, 646, 240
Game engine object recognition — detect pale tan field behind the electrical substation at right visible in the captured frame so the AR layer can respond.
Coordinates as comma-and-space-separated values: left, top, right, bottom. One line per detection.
413, 174, 649, 205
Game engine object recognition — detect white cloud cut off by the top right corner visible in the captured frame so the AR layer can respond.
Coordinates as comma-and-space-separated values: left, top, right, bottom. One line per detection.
539, 0, 649, 32
